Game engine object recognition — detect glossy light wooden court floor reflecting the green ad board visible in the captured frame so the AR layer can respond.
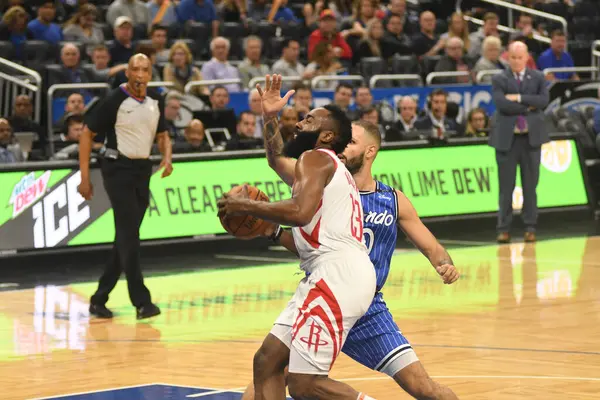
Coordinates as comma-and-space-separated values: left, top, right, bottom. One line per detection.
0, 237, 600, 400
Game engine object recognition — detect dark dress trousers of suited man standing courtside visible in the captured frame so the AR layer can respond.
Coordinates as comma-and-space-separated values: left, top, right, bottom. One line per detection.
496, 134, 542, 233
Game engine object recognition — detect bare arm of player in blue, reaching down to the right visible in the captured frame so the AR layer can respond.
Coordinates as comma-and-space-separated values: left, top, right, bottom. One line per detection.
396, 190, 459, 283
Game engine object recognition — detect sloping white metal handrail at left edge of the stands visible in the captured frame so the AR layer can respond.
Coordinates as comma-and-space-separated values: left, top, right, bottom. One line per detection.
0, 57, 42, 124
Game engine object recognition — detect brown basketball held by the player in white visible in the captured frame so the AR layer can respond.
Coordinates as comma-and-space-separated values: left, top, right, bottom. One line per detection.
217, 185, 272, 240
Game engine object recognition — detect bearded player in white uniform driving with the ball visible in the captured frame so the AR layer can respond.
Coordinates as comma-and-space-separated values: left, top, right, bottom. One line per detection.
218, 75, 376, 400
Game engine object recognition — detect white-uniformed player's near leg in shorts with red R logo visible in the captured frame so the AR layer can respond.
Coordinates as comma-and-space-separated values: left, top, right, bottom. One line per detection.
288, 255, 375, 400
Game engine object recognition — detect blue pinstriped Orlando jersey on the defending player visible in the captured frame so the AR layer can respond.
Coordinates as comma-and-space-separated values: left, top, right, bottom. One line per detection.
360, 181, 398, 292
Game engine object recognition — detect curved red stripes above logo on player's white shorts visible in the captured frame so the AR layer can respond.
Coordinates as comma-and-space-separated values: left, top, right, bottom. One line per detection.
292, 279, 344, 369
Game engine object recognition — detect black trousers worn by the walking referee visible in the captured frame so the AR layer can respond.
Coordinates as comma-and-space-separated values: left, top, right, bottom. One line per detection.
91, 157, 152, 308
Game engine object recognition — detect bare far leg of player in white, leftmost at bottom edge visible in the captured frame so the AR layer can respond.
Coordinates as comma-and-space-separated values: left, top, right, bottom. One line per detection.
253, 325, 290, 400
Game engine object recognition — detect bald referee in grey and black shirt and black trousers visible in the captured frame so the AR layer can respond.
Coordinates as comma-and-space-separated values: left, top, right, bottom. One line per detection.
78, 54, 173, 319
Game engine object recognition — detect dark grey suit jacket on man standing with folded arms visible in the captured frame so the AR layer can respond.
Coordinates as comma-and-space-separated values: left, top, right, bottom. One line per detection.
489, 68, 550, 151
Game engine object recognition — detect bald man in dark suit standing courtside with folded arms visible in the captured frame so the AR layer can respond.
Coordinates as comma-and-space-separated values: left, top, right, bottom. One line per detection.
490, 42, 550, 243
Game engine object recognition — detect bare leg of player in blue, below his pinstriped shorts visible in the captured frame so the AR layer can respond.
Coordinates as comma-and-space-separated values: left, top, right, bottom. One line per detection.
393, 361, 458, 400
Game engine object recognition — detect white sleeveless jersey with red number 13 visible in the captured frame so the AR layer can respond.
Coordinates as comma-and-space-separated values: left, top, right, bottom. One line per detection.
292, 149, 367, 271
